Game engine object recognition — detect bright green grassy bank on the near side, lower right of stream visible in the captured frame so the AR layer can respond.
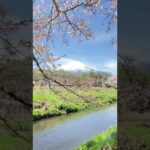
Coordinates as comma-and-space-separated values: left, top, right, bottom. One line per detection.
76, 127, 117, 150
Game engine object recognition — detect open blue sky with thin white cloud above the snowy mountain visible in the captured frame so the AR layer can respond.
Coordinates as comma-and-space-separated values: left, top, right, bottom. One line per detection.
53, 11, 117, 74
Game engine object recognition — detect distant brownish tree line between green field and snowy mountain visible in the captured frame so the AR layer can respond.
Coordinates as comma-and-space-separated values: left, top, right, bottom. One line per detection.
33, 69, 117, 88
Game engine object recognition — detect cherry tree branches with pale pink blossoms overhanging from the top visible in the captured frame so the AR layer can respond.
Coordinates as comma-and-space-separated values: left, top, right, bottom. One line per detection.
33, 0, 117, 90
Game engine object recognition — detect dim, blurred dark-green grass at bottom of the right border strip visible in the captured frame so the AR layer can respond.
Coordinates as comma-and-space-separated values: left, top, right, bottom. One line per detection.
118, 116, 150, 150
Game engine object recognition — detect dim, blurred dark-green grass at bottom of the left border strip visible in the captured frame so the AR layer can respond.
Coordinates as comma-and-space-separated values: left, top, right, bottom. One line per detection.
0, 117, 32, 150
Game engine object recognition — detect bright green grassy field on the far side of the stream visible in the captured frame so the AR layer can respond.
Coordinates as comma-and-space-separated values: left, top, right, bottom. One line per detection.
33, 88, 117, 120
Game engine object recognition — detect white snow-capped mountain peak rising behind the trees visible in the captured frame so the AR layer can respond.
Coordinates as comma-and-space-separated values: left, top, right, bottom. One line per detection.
57, 61, 92, 72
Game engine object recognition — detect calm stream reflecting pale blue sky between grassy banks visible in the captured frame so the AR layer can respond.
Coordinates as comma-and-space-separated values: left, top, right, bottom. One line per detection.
33, 105, 117, 150
